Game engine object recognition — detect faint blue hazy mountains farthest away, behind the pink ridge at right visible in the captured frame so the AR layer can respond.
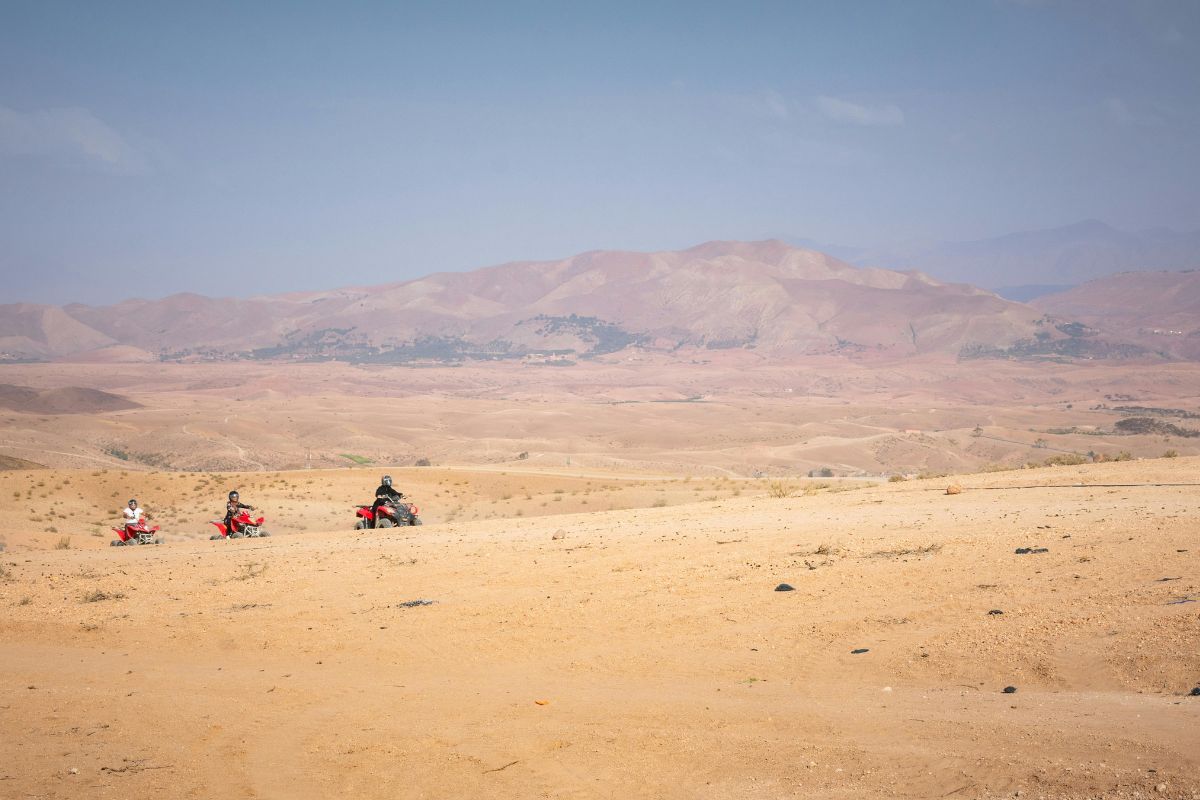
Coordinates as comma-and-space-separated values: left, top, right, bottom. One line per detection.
787, 219, 1200, 297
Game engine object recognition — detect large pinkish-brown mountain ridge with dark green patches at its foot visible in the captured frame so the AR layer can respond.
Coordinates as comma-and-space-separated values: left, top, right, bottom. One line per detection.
0, 240, 1161, 362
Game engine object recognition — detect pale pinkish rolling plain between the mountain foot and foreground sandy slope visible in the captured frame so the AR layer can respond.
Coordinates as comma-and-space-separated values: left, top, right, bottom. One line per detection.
0, 359, 1200, 479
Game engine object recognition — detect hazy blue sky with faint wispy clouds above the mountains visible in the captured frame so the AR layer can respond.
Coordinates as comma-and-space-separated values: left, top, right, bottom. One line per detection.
0, 0, 1200, 305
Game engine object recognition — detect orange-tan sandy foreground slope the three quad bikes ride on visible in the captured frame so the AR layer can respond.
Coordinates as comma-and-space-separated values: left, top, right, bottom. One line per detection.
0, 458, 1200, 799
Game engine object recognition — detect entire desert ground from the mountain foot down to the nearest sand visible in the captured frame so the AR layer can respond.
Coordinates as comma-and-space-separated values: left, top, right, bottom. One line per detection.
0, 361, 1200, 799
